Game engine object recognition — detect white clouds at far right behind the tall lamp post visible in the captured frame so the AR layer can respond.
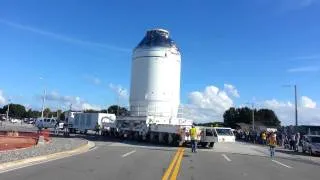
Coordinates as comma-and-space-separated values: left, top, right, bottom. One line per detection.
263, 96, 320, 125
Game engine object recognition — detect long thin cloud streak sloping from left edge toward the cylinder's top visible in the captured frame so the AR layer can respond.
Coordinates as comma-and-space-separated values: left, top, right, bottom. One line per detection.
0, 19, 131, 52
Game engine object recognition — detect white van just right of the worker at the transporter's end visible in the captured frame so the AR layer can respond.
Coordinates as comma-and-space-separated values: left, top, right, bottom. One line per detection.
213, 127, 236, 142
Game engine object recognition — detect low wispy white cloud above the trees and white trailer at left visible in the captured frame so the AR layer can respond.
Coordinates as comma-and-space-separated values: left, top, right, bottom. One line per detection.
40, 91, 102, 110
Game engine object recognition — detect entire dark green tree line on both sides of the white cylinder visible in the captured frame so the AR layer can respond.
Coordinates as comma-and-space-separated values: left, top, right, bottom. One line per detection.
0, 104, 281, 128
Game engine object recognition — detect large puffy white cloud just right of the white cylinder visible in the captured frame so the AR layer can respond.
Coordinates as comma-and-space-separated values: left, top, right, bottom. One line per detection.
182, 86, 235, 122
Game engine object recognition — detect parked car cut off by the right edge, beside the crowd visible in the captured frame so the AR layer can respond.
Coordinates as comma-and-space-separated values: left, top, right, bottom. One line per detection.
302, 135, 320, 155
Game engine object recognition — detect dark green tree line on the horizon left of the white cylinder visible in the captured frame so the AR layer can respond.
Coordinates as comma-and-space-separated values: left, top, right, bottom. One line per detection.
0, 104, 129, 120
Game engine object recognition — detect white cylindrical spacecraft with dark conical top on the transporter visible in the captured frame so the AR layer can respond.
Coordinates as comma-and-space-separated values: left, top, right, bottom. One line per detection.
129, 29, 181, 118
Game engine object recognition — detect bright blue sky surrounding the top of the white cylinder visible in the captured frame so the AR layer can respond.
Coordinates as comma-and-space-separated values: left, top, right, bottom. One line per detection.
0, 0, 320, 124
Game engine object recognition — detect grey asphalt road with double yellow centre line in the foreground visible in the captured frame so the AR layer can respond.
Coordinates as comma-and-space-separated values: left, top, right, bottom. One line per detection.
0, 141, 320, 180
